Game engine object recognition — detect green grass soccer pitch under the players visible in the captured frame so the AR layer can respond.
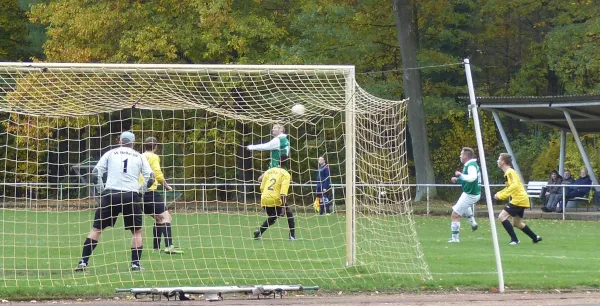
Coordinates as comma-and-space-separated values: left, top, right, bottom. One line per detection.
0, 210, 600, 298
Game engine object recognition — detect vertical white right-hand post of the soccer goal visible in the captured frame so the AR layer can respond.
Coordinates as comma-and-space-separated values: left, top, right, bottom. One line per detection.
345, 69, 356, 267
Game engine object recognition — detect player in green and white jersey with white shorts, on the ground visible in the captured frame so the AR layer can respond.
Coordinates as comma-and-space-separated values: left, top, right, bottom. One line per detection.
448, 148, 481, 242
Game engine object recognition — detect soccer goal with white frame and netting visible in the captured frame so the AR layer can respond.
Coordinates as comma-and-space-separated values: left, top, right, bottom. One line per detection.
0, 63, 430, 292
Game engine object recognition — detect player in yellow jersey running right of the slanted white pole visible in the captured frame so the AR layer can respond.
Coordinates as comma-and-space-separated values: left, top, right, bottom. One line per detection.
494, 153, 542, 245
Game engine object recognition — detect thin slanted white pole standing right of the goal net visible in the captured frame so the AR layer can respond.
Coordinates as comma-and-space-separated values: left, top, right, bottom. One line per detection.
464, 59, 504, 292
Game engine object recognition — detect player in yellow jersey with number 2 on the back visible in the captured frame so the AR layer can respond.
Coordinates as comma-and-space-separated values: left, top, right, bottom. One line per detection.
254, 154, 296, 240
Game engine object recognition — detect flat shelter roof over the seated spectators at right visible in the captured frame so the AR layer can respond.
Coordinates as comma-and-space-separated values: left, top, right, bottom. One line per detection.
461, 94, 600, 134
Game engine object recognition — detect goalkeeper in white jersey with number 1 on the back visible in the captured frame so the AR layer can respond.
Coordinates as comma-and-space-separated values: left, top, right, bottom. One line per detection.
75, 132, 153, 271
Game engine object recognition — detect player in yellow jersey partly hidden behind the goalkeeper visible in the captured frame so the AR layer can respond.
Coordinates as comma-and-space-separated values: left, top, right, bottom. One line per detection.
142, 137, 183, 254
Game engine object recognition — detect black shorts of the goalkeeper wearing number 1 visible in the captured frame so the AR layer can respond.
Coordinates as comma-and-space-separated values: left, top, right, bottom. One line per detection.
93, 189, 143, 230
